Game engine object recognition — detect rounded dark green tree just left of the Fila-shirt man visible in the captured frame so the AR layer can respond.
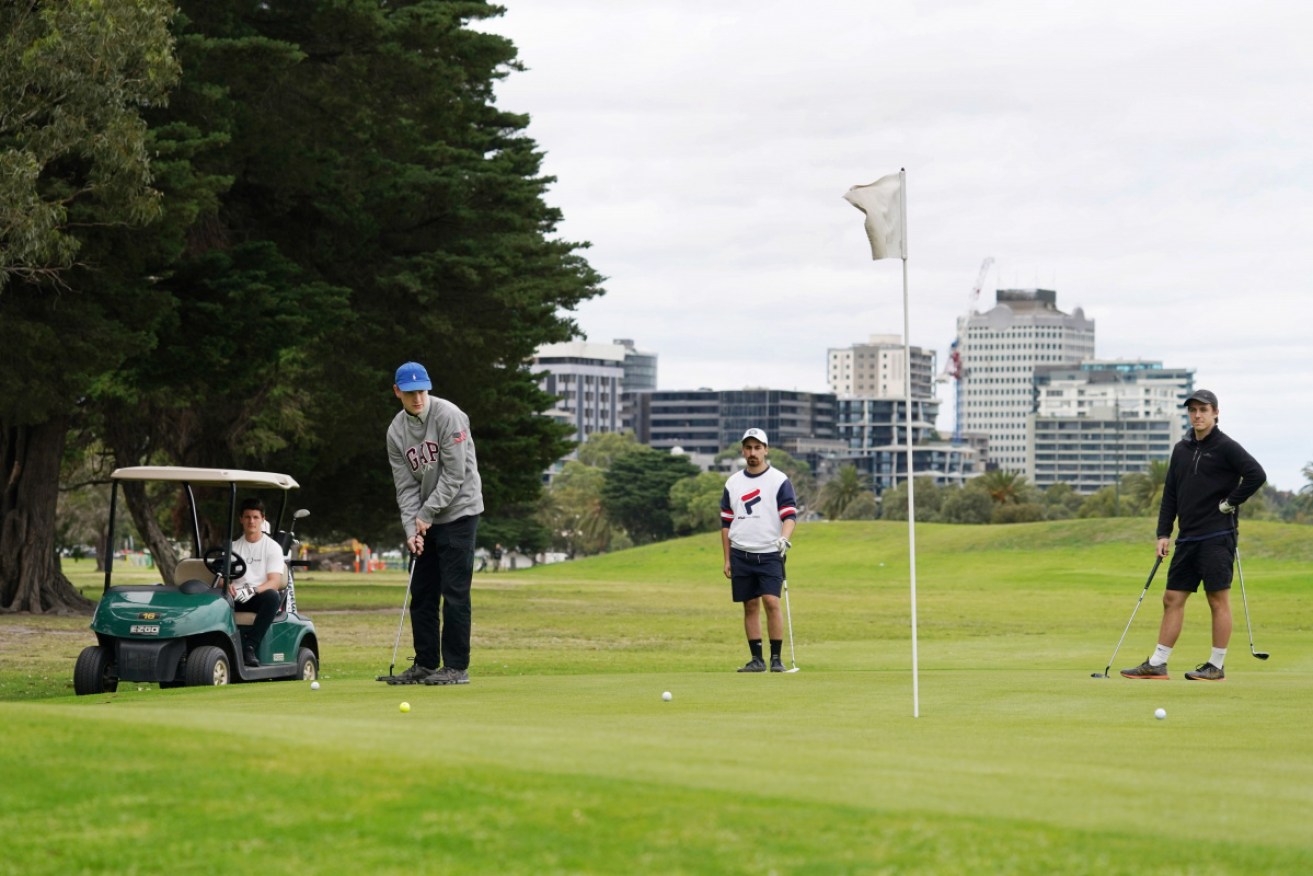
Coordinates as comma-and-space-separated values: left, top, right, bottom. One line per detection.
601, 447, 697, 545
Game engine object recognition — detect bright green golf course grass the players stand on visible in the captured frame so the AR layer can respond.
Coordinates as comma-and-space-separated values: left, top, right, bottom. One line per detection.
0, 520, 1313, 873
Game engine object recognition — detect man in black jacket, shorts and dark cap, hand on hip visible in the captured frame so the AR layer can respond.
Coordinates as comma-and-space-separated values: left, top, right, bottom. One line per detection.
1121, 389, 1267, 682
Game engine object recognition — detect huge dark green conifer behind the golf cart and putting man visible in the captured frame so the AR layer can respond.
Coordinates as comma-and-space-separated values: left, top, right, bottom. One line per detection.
84, 0, 601, 551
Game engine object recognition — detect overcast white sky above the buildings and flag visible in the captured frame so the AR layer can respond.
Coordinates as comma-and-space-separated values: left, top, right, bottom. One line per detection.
482, 0, 1313, 490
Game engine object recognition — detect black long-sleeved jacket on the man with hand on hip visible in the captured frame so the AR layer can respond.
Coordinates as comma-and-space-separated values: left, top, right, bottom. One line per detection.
1158, 426, 1267, 541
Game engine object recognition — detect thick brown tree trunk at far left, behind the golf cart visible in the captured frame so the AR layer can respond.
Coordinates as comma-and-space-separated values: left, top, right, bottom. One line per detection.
0, 416, 95, 615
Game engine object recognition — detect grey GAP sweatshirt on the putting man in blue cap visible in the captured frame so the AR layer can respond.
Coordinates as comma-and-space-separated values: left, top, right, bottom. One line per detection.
387, 395, 483, 538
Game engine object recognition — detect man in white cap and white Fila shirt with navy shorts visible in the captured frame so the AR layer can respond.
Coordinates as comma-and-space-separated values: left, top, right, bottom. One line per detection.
721, 428, 798, 672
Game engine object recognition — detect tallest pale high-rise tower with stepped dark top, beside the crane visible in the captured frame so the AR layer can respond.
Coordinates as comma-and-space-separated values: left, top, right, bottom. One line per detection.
958, 289, 1094, 473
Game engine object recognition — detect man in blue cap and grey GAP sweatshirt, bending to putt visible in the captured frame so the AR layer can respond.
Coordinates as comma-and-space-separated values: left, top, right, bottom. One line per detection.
386, 362, 483, 684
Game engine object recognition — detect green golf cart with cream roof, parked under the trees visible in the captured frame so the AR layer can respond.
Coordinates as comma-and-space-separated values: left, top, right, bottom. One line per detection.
74, 466, 319, 695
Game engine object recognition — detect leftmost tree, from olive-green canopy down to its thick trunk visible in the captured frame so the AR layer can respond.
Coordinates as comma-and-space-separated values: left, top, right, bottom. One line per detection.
0, 0, 177, 612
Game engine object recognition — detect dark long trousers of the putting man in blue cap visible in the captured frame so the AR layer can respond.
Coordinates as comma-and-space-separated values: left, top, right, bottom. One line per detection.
411, 515, 479, 670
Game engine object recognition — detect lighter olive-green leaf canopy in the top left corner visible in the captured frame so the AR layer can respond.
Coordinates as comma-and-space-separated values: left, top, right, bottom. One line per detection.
0, 0, 177, 294
